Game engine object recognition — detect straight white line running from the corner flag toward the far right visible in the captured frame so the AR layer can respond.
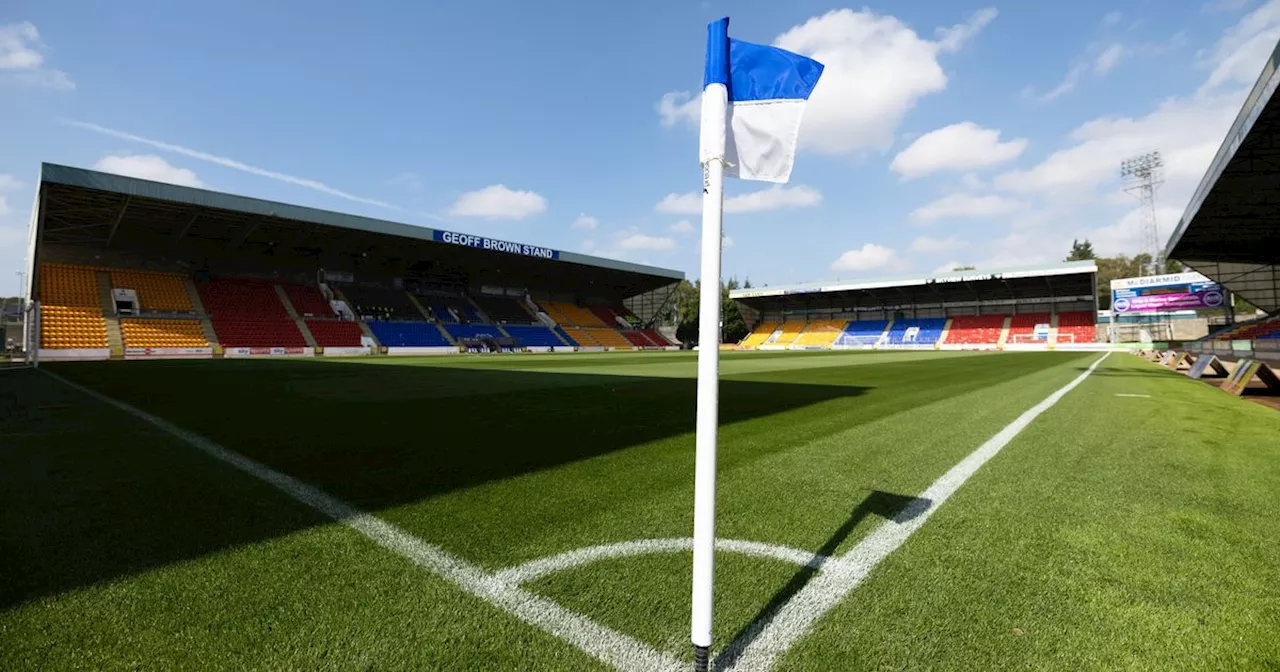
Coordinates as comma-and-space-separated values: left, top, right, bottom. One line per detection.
716, 352, 1111, 672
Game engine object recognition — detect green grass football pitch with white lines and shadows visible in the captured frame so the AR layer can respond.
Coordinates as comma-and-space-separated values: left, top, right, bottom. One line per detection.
0, 352, 1280, 671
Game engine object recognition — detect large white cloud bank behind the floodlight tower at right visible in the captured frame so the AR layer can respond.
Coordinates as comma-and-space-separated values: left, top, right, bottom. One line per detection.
978, 0, 1280, 268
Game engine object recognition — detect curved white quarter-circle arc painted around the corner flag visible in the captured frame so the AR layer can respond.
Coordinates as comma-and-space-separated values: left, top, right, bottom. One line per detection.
494, 536, 831, 585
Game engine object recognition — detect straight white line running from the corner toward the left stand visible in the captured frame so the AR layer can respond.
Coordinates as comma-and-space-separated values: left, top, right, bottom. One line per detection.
45, 371, 687, 672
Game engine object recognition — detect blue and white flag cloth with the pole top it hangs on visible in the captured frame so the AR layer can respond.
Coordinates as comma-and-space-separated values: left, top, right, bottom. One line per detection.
699, 17, 822, 183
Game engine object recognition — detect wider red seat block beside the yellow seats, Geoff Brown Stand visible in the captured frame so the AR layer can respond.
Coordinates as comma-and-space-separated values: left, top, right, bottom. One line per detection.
200, 278, 307, 348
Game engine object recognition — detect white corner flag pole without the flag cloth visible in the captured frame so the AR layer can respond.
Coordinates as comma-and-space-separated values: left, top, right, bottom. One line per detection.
690, 75, 728, 672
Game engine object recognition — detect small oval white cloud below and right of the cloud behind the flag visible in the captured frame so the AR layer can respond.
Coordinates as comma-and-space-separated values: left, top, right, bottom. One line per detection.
890, 122, 1027, 179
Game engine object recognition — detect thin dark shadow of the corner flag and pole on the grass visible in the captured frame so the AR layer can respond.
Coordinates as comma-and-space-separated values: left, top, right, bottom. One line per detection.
716, 490, 931, 671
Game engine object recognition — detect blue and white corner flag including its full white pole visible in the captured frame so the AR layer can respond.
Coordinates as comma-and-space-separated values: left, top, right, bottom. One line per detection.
690, 18, 822, 672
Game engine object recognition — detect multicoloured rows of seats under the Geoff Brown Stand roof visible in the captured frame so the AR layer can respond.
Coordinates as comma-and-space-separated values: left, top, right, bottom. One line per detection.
33, 264, 669, 349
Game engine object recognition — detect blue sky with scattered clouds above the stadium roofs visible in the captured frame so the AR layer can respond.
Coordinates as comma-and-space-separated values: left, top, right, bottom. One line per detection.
0, 0, 1280, 294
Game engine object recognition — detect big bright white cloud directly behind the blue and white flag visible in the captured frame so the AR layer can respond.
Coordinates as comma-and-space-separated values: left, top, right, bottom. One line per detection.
657, 8, 996, 155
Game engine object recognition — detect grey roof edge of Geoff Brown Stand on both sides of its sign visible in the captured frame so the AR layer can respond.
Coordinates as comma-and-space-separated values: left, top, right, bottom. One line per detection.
40, 163, 685, 280
